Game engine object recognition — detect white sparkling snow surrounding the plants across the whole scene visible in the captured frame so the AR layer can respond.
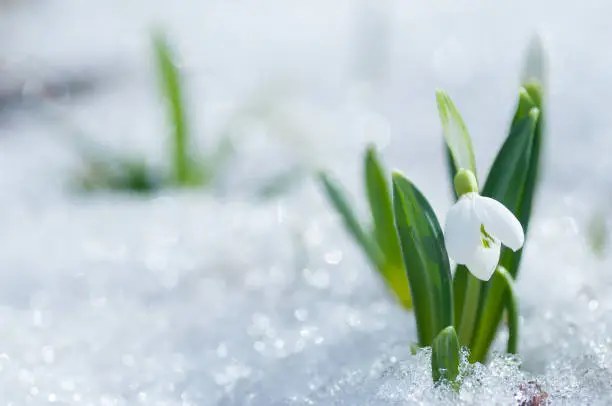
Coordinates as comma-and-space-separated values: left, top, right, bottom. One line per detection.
0, 0, 612, 406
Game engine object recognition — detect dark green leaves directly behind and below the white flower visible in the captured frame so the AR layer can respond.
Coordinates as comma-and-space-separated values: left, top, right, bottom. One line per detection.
449, 82, 544, 361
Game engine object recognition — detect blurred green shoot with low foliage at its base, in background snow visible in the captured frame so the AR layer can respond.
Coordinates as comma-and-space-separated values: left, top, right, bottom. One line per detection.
80, 32, 234, 193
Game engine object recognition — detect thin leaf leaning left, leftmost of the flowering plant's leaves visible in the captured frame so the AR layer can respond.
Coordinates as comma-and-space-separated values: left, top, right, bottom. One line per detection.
318, 172, 384, 270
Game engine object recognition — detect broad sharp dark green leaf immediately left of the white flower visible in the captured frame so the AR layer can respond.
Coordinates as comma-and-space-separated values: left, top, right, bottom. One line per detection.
393, 172, 453, 346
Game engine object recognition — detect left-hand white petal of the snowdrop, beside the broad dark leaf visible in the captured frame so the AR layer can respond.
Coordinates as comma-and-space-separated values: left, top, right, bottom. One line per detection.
444, 193, 481, 264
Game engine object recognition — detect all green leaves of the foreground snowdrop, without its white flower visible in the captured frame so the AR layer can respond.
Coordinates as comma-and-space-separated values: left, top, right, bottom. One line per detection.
322, 38, 544, 384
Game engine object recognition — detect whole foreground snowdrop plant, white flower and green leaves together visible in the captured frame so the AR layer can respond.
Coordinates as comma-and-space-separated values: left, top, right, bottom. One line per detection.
321, 39, 544, 388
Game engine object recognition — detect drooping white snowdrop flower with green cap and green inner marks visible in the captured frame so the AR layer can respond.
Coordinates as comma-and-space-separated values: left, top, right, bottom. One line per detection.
444, 169, 525, 281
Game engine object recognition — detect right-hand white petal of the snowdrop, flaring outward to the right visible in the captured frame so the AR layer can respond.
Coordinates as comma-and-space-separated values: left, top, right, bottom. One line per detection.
474, 196, 525, 251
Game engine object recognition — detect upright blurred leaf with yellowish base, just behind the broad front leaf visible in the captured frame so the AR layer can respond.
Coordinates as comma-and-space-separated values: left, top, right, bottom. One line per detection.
364, 146, 412, 309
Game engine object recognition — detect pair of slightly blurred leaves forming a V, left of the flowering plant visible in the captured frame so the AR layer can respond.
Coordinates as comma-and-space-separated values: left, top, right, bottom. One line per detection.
319, 146, 412, 309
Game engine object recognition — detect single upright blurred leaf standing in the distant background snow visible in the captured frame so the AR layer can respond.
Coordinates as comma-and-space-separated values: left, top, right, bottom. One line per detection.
153, 33, 193, 186
